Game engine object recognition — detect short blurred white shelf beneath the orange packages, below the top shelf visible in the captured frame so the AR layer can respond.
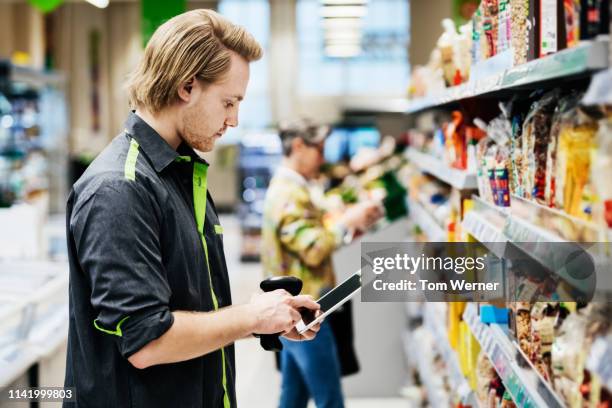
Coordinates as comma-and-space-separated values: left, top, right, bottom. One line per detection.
406, 149, 478, 190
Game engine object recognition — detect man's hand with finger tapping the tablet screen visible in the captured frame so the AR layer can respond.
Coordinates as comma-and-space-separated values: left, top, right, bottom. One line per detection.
248, 289, 320, 337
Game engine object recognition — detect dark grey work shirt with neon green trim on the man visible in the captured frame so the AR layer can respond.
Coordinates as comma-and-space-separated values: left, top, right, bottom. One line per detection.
64, 113, 236, 408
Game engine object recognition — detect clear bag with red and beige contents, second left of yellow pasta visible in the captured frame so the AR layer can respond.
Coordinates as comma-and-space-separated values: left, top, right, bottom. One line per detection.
519, 89, 559, 202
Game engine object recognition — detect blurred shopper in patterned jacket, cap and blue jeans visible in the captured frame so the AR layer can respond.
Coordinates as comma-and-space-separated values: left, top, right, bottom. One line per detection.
261, 120, 382, 408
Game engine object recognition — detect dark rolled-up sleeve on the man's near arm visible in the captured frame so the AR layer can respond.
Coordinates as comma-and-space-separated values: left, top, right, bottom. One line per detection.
70, 180, 173, 358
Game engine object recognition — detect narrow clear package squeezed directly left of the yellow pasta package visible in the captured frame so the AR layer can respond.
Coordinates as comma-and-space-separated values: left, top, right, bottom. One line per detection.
544, 92, 582, 207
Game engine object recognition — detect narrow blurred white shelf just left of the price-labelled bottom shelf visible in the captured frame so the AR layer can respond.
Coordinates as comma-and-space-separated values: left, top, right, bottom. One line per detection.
423, 303, 473, 401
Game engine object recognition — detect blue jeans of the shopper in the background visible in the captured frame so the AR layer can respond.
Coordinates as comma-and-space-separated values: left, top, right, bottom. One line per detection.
280, 322, 344, 408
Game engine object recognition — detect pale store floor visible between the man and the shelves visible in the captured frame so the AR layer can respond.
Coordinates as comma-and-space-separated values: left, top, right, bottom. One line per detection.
221, 215, 411, 408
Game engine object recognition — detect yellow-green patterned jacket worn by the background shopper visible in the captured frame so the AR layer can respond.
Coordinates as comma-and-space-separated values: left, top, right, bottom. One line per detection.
261, 167, 344, 299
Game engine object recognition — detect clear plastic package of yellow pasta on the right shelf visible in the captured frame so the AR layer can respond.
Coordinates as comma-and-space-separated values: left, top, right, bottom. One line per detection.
555, 108, 597, 219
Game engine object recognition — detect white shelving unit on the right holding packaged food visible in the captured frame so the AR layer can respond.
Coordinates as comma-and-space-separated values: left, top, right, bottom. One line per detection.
404, 37, 612, 408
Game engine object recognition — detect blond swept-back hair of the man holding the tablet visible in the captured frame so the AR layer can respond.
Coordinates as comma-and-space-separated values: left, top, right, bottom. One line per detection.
127, 9, 263, 113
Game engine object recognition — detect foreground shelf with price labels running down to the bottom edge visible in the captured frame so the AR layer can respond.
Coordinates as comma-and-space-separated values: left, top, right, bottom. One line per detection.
463, 303, 565, 408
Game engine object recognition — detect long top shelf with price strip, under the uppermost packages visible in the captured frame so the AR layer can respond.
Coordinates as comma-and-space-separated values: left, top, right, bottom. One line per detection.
406, 40, 608, 113
